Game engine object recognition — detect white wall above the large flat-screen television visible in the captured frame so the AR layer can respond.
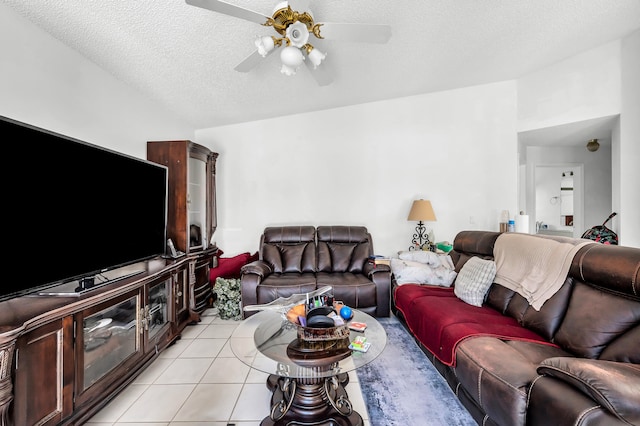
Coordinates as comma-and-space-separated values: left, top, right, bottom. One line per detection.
0, 4, 193, 158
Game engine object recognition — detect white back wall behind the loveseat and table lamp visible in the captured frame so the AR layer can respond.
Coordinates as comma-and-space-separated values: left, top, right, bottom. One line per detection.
196, 81, 517, 255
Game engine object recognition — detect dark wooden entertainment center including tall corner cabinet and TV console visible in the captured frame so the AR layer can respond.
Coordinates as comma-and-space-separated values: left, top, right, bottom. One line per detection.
0, 141, 220, 426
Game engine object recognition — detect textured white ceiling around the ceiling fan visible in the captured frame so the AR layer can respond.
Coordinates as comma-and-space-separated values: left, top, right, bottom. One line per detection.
5, 0, 640, 128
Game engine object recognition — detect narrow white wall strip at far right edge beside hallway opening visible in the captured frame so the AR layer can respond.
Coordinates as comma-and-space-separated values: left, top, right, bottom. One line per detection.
614, 31, 640, 247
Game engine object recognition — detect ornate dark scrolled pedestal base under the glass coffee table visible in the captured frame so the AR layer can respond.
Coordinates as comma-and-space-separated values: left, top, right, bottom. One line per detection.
260, 373, 364, 426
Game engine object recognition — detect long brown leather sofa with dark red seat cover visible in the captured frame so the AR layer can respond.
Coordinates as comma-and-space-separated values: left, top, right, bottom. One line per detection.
392, 231, 640, 426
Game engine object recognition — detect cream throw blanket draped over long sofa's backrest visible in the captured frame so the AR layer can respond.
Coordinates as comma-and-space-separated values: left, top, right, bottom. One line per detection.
493, 232, 595, 311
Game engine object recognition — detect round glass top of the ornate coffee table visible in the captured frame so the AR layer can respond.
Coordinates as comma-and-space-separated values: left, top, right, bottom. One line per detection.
229, 309, 387, 378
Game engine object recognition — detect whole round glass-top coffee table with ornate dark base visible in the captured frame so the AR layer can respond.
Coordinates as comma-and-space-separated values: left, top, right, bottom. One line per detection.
230, 309, 387, 426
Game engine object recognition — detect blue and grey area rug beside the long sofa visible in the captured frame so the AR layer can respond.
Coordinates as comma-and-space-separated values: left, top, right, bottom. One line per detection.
356, 316, 476, 426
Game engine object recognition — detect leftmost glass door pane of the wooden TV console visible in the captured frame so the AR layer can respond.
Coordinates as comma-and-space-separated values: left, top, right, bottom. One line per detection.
81, 293, 140, 390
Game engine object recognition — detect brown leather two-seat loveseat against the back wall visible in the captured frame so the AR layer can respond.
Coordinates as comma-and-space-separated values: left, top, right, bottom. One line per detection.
240, 226, 391, 318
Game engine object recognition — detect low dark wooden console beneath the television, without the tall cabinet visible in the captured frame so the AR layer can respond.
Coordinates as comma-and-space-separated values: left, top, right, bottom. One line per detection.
0, 247, 218, 426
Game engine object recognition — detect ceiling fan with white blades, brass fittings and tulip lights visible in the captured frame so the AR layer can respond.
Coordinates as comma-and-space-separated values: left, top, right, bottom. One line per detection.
185, 0, 391, 86
